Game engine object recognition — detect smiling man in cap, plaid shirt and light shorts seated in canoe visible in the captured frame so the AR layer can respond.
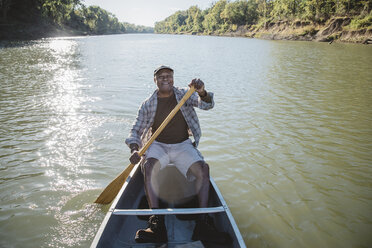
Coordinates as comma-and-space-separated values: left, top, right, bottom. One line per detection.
125, 66, 228, 243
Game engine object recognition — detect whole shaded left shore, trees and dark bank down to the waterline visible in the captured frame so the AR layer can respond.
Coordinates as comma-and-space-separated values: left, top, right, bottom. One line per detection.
0, 0, 154, 40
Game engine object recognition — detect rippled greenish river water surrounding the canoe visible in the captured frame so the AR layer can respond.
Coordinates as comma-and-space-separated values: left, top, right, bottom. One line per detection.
0, 34, 372, 248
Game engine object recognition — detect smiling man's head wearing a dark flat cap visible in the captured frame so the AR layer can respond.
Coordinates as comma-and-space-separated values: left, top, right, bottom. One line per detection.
154, 65, 174, 97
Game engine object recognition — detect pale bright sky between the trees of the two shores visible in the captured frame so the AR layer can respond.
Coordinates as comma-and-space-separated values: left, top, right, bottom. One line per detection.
82, 0, 217, 27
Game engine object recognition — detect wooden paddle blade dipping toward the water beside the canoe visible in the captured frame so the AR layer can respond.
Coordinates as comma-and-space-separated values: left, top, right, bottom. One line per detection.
94, 164, 134, 204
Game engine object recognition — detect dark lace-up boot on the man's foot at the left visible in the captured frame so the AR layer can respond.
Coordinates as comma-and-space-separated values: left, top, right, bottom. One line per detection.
134, 215, 168, 243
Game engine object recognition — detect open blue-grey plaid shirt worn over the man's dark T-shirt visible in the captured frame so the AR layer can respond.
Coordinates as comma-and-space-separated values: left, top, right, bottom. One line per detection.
125, 87, 214, 148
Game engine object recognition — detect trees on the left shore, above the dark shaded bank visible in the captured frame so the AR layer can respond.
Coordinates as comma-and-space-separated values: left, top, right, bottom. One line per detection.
0, 0, 153, 34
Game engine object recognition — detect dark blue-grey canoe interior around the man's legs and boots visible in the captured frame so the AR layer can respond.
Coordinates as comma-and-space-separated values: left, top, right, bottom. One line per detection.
92, 166, 242, 248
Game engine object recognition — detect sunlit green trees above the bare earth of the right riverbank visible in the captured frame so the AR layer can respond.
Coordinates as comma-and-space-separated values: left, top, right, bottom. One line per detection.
155, 0, 372, 34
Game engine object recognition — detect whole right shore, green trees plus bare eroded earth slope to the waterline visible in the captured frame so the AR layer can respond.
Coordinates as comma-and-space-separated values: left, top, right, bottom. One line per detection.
154, 0, 372, 44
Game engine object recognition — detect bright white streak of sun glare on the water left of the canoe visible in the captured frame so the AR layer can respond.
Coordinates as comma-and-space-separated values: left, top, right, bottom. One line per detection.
37, 39, 102, 246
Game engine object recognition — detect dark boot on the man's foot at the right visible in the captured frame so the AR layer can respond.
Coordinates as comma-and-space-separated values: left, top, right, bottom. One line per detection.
192, 214, 232, 245
